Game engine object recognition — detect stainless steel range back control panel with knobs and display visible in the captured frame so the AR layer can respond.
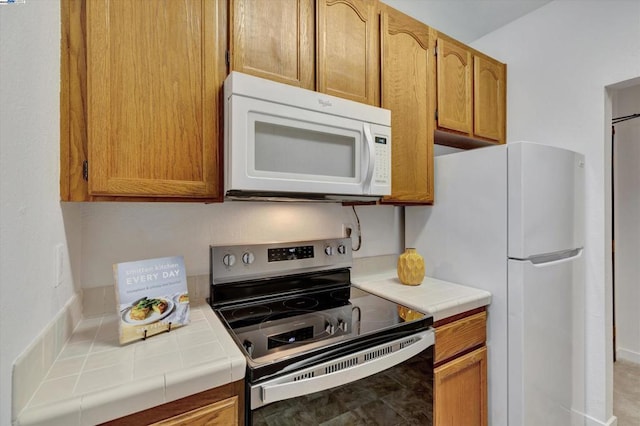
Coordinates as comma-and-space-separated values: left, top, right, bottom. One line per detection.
210, 238, 352, 284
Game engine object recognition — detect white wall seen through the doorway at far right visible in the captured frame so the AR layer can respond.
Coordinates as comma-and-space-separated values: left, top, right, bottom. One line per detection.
613, 85, 640, 363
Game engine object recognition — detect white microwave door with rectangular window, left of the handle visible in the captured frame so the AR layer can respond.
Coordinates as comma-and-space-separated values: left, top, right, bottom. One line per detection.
225, 97, 375, 195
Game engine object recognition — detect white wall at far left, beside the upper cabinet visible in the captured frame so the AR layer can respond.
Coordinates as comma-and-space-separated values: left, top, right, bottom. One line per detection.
0, 0, 80, 425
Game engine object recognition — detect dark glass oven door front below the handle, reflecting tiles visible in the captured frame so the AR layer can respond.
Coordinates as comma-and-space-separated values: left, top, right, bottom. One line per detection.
253, 353, 433, 426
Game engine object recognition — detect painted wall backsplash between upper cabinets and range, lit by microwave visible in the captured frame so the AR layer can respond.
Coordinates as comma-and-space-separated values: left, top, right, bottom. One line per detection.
77, 201, 404, 289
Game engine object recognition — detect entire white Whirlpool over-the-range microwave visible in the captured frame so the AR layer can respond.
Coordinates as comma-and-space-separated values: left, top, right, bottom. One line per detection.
224, 71, 391, 201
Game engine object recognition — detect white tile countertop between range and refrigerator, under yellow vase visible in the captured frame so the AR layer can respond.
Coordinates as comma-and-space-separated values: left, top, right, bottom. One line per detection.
351, 270, 491, 322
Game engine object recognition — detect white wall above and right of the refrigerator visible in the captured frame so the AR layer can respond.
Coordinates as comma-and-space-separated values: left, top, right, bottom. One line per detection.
472, 0, 640, 425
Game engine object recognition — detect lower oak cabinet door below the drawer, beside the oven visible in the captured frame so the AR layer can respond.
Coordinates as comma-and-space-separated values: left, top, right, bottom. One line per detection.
433, 347, 488, 426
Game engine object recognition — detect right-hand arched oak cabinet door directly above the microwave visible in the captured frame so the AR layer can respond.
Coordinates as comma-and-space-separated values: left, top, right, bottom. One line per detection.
316, 0, 380, 105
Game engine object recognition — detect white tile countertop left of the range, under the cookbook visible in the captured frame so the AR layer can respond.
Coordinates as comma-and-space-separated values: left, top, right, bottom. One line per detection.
15, 300, 246, 426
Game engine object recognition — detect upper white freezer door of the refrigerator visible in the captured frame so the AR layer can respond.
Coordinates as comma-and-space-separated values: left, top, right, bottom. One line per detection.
507, 142, 584, 259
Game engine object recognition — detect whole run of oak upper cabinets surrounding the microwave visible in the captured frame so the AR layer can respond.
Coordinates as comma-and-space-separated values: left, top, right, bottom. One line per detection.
60, 0, 506, 204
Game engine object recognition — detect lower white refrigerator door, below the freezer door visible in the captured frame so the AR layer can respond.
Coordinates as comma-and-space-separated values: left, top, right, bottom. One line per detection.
508, 250, 584, 426
